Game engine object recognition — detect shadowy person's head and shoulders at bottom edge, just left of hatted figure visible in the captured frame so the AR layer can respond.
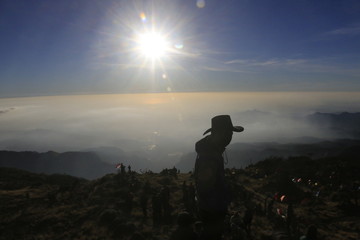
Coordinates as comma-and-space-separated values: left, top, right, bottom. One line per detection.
170, 212, 198, 240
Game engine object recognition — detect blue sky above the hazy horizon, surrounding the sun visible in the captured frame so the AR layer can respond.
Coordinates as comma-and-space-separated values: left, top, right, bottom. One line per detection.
0, 0, 360, 97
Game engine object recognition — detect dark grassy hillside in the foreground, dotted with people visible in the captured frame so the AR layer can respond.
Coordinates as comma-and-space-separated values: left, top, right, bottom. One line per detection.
0, 156, 360, 240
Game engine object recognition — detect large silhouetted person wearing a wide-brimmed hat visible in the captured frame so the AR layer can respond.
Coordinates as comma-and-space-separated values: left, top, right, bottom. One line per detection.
194, 115, 244, 240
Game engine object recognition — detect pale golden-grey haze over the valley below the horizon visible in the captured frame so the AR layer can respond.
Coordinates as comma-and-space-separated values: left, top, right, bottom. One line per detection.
0, 92, 360, 174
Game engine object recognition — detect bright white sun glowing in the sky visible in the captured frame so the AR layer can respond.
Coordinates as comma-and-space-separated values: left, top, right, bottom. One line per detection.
136, 32, 170, 60
